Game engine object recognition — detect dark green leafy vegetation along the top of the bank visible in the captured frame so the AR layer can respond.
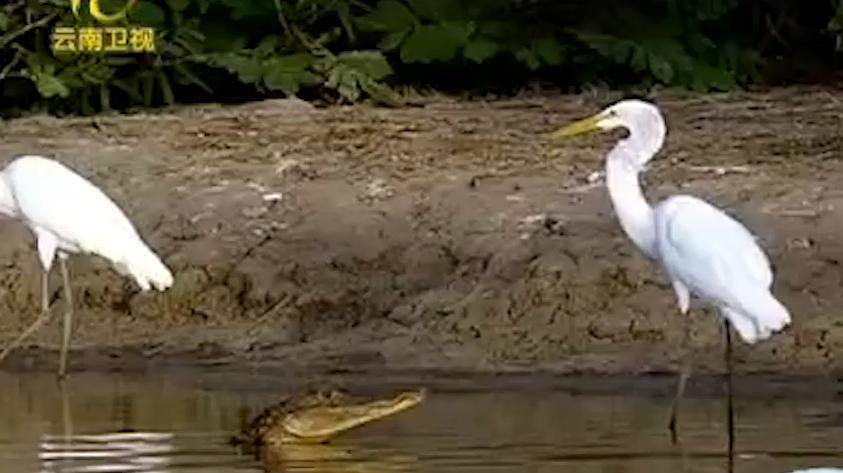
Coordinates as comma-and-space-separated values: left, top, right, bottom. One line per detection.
0, 0, 843, 113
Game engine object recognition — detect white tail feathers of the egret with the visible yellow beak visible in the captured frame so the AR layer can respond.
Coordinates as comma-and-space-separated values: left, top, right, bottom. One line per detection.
723, 291, 790, 344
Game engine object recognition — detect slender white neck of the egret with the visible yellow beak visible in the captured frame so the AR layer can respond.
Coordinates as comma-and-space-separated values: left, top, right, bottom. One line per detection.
606, 139, 656, 258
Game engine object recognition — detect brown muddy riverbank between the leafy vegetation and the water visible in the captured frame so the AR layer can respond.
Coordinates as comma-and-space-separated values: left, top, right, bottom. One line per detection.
0, 89, 843, 374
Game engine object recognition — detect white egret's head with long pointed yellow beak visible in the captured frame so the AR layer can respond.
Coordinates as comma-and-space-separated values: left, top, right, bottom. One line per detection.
550, 99, 666, 169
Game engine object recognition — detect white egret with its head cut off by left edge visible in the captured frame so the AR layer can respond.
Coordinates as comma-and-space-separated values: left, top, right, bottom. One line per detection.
0, 156, 173, 377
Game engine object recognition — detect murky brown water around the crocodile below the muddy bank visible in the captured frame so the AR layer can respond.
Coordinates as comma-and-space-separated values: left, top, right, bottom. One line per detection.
0, 373, 843, 473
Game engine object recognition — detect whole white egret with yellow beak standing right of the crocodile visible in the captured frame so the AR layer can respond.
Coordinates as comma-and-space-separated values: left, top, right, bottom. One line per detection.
551, 100, 790, 446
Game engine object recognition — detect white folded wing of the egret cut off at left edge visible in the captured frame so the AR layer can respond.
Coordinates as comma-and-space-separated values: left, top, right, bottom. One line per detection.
5, 156, 138, 257
